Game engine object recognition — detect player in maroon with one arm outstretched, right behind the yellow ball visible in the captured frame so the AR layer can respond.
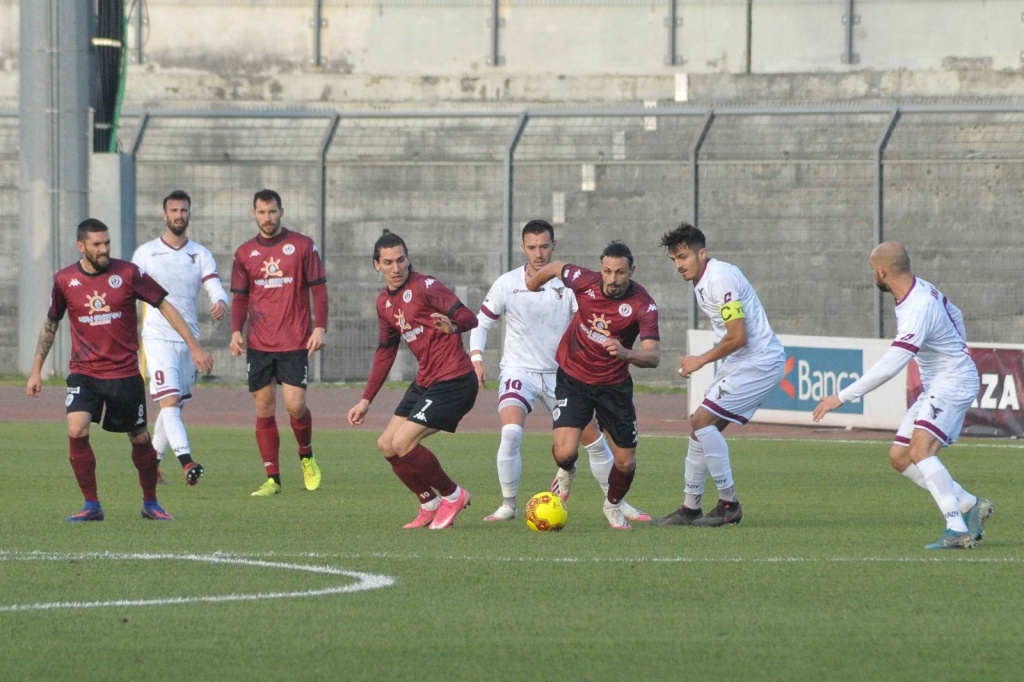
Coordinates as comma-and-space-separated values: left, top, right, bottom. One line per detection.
526, 242, 662, 530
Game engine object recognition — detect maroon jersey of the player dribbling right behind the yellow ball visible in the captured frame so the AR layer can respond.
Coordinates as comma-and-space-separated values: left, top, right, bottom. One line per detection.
555, 264, 658, 386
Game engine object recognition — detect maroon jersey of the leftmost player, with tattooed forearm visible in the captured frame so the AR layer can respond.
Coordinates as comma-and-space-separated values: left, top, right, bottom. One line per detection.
46, 258, 167, 379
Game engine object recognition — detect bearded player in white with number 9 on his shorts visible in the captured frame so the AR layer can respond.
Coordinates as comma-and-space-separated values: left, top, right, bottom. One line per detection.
132, 189, 227, 485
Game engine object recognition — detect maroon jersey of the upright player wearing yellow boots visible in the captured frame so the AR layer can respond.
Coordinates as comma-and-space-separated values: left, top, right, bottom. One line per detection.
231, 228, 327, 352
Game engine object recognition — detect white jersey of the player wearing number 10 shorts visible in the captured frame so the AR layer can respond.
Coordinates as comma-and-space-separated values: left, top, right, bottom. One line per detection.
469, 265, 577, 372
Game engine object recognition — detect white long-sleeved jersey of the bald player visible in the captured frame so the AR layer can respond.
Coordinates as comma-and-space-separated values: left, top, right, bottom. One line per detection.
839, 278, 979, 402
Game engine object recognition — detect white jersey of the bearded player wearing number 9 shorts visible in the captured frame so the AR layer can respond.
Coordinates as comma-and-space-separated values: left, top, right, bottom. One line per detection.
131, 238, 227, 341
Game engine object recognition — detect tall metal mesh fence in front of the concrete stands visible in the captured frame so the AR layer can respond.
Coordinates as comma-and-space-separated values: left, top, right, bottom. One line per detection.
8, 106, 1024, 382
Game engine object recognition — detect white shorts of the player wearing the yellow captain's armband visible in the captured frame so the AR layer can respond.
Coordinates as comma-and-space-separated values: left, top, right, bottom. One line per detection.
700, 359, 785, 425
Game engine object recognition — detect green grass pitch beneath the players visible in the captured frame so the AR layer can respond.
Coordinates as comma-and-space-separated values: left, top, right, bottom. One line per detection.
0, 422, 1024, 682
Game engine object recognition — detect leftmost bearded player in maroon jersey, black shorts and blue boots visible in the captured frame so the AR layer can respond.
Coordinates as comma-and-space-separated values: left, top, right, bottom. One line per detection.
26, 218, 213, 521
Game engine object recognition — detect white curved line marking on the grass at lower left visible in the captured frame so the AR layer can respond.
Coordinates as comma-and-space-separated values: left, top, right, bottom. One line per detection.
0, 551, 394, 613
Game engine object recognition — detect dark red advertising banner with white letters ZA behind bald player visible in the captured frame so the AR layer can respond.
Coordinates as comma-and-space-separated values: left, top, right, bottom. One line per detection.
906, 344, 1024, 437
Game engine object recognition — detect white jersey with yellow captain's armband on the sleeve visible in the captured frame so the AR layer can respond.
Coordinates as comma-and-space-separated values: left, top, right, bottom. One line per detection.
693, 258, 785, 363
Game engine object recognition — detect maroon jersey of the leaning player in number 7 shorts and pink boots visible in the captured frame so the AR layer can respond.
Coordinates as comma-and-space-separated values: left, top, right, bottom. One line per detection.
377, 272, 476, 387
